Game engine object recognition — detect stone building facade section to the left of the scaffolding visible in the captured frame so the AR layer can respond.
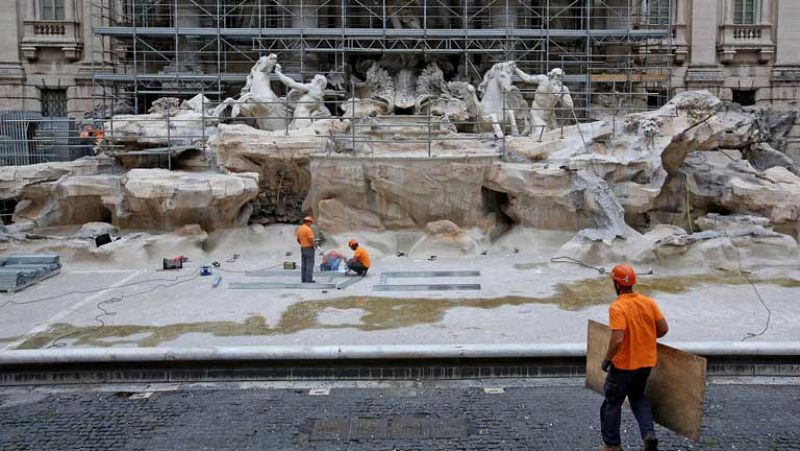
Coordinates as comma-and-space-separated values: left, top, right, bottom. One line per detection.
0, 0, 92, 118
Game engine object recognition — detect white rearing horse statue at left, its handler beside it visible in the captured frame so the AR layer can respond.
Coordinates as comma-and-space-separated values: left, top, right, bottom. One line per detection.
214, 53, 291, 130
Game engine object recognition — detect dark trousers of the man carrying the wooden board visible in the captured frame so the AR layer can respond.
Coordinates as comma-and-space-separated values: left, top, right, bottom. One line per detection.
600, 366, 656, 446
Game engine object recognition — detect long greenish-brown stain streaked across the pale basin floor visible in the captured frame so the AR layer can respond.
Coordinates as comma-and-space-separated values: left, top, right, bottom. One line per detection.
14, 274, 800, 349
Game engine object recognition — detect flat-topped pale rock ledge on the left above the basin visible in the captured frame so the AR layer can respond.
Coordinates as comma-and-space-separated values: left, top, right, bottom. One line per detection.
0, 157, 258, 232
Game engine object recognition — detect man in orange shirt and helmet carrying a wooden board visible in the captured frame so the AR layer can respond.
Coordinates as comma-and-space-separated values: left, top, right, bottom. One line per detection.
600, 263, 669, 451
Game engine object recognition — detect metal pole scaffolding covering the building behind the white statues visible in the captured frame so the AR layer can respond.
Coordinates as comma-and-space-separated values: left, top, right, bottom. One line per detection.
91, 0, 672, 119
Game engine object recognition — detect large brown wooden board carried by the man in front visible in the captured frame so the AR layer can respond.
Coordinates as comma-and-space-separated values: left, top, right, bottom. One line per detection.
586, 320, 706, 442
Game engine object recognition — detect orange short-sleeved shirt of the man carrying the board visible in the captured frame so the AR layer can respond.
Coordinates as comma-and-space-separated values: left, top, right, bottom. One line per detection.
608, 293, 664, 370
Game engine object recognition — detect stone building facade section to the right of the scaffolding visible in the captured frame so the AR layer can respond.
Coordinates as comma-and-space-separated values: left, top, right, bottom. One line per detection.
672, 0, 800, 109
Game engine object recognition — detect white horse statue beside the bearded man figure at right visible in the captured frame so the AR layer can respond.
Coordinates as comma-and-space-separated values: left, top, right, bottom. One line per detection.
475, 61, 529, 138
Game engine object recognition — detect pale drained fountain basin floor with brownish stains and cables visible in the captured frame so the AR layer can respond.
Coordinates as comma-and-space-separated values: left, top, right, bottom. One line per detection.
0, 225, 800, 349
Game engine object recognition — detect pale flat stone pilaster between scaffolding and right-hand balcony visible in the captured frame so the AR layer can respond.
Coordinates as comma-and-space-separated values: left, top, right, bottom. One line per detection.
686, 0, 725, 89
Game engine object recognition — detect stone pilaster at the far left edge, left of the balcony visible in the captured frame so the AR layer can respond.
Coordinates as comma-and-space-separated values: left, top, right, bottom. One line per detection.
0, 0, 25, 110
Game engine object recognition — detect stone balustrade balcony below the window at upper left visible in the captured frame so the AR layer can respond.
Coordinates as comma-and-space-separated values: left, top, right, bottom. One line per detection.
20, 20, 83, 61
